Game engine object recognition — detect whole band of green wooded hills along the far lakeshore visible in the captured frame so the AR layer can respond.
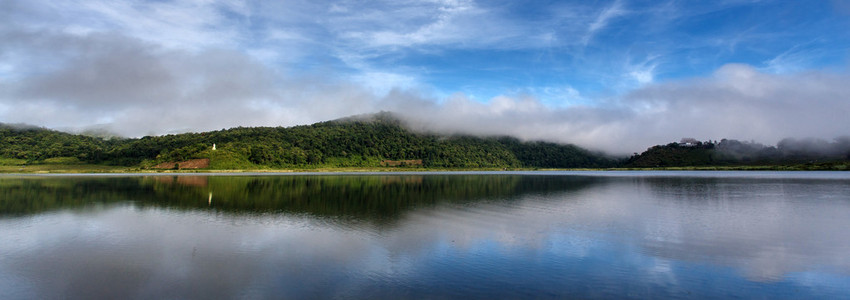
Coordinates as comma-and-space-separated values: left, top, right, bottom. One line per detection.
0, 113, 850, 170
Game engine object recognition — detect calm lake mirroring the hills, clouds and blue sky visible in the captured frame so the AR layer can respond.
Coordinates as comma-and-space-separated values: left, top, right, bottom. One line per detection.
0, 171, 850, 299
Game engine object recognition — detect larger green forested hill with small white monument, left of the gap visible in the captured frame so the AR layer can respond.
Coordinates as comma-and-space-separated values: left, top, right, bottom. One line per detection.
0, 113, 617, 169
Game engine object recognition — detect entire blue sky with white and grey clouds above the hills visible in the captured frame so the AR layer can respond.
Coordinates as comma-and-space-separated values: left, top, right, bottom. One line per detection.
0, 0, 850, 154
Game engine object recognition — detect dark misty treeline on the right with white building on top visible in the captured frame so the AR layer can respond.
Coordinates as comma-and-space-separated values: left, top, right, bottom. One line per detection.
623, 137, 850, 169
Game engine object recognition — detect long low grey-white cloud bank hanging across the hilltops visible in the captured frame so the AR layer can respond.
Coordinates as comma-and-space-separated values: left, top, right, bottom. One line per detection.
0, 27, 850, 154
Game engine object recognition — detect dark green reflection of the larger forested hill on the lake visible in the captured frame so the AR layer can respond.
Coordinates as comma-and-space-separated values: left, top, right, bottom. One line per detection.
0, 175, 592, 222
